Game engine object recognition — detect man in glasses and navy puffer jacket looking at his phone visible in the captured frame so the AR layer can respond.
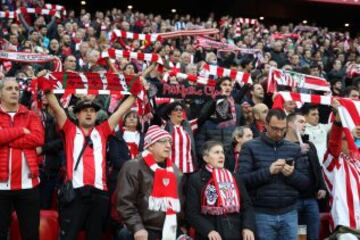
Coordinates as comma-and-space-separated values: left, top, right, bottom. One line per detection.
239, 109, 310, 240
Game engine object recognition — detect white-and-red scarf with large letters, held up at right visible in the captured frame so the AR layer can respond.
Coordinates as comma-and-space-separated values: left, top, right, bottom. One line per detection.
267, 68, 330, 93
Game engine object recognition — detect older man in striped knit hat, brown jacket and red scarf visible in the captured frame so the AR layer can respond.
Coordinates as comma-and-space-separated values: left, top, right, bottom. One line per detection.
117, 125, 180, 240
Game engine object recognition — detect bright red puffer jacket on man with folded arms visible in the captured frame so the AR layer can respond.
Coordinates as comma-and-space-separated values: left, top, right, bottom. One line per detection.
0, 105, 44, 181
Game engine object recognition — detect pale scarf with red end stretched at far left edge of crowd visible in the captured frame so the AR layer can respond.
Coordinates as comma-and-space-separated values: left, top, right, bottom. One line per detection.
0, 51, 62, 71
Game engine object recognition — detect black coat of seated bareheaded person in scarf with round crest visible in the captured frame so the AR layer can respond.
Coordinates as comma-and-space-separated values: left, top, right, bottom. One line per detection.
186, 168, 255, 240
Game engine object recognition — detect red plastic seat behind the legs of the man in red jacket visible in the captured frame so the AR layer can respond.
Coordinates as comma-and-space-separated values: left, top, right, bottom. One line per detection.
10, 210, 60, 240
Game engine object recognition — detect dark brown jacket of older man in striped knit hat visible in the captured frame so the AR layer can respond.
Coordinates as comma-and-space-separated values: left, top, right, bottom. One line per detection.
117, 156, 181, 233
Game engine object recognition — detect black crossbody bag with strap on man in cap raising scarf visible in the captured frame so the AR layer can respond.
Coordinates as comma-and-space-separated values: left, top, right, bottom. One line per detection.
58, 136, 92, 205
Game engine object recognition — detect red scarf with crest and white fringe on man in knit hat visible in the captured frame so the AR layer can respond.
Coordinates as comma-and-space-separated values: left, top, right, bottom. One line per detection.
142, 150, 180, 240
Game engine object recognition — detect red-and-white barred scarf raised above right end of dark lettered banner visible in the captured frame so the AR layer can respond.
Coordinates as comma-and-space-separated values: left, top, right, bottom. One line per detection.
201, 64, 252, 85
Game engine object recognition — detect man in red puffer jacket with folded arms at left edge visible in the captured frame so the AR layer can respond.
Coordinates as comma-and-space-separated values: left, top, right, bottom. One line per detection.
0, 78, 44, 240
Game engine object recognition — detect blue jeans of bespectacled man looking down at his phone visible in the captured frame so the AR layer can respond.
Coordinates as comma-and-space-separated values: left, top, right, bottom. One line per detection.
255, 210, 298, 240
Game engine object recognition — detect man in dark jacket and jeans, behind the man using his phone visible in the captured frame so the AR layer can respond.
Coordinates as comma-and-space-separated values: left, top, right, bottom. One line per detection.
285, 113, 326, 240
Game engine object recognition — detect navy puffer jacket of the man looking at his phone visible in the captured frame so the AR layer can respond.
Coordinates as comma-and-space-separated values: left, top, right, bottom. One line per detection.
239, 134, 310, 214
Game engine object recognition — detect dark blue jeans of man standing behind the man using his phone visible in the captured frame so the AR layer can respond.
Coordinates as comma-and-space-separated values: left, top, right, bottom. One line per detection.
297, 198, 320, 240
